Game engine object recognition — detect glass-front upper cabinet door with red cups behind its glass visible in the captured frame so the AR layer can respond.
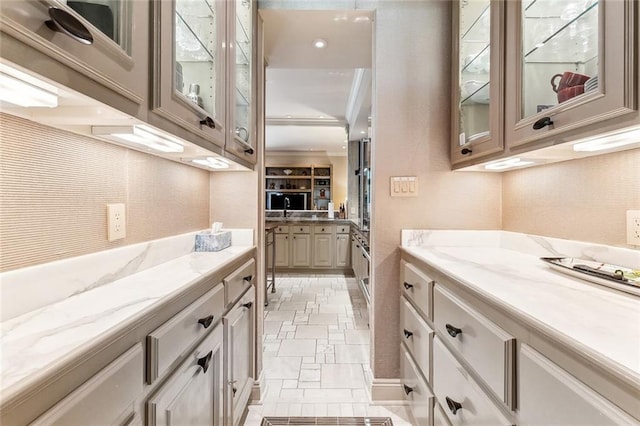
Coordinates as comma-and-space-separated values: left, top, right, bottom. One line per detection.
506, 0, 638, 147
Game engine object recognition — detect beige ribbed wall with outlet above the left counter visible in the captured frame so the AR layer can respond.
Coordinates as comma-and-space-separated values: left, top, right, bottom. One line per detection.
0, 114, 209, 271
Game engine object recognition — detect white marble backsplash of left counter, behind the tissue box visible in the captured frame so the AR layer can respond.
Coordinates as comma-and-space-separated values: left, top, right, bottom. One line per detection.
0, 229, 253, 322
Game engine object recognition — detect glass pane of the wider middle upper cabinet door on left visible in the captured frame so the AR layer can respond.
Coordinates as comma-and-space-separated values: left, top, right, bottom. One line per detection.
174, 0, 224, 118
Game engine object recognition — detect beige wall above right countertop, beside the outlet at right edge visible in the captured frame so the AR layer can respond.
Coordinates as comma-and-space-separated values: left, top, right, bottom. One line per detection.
502, 149, 640, 247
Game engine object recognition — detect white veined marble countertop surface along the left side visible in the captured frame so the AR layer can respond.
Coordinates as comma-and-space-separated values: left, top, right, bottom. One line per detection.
0, 236, 254, 402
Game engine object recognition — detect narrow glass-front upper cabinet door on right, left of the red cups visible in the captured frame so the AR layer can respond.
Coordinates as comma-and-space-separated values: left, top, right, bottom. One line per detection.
451, 0, 504, 164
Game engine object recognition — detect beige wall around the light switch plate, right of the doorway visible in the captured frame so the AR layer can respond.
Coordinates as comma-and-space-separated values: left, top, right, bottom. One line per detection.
371, 0, 501, 379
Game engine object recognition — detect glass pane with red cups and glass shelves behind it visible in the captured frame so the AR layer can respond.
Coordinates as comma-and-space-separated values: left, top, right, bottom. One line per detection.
521, 0, 596, 118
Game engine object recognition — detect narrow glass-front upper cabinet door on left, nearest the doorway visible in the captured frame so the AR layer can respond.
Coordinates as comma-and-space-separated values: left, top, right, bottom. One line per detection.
227, 0, 257, 163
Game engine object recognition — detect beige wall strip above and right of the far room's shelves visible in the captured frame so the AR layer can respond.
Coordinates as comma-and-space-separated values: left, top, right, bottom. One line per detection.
265, 152, 347, 209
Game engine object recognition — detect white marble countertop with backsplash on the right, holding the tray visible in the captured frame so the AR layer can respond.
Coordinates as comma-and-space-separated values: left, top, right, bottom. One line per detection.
402, 231, 640, 386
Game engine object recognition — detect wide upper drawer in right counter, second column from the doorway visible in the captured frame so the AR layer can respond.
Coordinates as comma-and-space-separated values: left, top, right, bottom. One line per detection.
433, 285, 515, 408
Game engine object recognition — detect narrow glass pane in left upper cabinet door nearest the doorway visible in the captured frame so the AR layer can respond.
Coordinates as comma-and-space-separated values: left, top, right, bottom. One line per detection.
234, 0, 253, 142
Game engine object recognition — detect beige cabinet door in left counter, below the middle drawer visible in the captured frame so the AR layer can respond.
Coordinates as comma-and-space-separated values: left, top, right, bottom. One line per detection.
147, 324, 225, 426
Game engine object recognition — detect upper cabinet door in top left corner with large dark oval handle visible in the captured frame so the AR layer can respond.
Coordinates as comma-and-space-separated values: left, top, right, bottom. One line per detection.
0, 0, 149, 115
